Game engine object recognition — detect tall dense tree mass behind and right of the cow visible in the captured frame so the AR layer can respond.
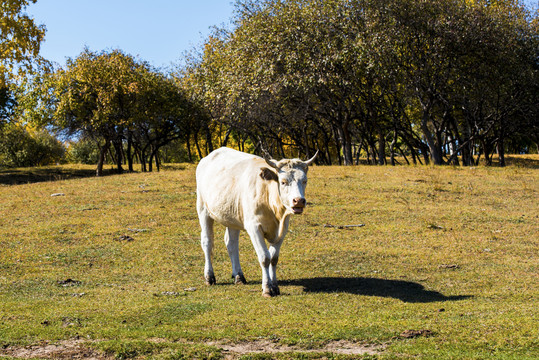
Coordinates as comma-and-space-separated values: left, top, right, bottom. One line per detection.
184, 0, 539, 165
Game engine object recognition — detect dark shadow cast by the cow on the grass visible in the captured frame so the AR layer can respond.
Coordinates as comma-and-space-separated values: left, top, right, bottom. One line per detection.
279, 277, 471, 303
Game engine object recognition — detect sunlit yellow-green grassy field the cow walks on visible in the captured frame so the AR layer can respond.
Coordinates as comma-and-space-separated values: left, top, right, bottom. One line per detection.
0, 156, 539, 360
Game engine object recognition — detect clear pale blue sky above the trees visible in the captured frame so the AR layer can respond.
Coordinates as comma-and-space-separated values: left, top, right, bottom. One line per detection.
26, 0, 233, 67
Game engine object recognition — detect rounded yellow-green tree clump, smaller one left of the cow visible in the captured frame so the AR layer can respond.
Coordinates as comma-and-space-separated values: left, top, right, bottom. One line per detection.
30, 49, 193, 176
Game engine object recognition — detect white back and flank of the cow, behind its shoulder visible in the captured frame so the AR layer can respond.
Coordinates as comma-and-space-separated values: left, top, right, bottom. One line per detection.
196, 148, 264, 229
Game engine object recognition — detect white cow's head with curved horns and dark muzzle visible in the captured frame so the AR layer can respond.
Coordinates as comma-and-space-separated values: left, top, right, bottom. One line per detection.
264, 151, 318, 214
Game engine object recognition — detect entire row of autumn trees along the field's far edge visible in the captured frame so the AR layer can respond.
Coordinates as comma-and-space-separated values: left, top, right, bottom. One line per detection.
0, 0, 539, 174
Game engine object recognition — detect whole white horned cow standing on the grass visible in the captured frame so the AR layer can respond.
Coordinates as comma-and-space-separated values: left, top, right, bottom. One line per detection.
196, 148, 318, 297
